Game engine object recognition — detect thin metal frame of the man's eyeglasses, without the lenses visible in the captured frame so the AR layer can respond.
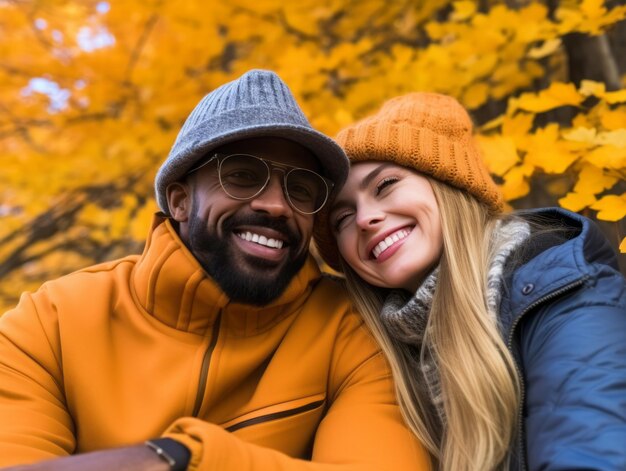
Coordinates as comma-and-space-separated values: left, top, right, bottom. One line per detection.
185, 152, 335, 215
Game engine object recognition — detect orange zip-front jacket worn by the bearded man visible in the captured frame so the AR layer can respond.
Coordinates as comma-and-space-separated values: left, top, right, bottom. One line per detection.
0, 219, 428, 471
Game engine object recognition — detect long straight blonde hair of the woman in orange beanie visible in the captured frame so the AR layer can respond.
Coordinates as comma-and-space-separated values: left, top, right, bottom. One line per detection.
342, 178, 520, 471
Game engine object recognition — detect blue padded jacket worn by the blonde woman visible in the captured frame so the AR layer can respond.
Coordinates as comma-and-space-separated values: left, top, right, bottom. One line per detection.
500, 208, 626, 471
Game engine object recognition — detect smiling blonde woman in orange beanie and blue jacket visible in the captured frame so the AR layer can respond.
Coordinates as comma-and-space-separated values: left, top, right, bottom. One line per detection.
316, 93, 626, 471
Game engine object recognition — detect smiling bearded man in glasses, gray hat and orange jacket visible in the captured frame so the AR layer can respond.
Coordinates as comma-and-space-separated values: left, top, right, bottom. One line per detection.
0, 70, 428, 471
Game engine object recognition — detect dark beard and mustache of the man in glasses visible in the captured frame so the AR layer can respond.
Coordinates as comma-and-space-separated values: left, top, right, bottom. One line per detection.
189, 205, 307, 306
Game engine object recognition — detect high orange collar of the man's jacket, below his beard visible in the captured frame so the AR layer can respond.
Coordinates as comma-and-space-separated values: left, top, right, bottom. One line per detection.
132, 214, 321, 336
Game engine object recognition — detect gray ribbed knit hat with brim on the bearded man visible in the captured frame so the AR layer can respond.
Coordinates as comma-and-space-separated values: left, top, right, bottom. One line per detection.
155, 70, 349, 214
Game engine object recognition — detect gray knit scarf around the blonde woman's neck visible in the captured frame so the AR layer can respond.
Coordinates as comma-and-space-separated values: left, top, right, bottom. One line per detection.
381, 220, 530, 427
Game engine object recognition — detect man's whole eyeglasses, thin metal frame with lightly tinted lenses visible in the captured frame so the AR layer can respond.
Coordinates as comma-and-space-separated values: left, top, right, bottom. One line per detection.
187, 154, 334, 214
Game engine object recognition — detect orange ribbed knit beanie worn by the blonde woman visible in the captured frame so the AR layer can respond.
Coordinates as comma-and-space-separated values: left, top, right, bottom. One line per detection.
314, 92, 503, 269
